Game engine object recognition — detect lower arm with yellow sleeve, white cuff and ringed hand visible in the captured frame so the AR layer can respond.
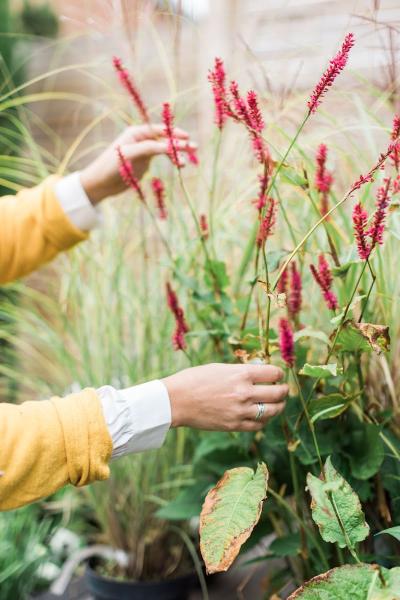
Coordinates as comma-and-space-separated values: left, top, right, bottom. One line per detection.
0, 364, 288, 510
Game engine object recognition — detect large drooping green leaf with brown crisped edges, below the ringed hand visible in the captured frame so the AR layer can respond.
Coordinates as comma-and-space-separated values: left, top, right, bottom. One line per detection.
200, 463, 268, 573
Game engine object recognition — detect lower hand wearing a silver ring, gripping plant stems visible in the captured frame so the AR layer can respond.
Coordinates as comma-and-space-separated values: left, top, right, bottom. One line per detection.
162, 364, 289, 431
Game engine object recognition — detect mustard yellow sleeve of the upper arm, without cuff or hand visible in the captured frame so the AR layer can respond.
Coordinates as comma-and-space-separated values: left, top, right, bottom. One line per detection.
0, 177, 87, 283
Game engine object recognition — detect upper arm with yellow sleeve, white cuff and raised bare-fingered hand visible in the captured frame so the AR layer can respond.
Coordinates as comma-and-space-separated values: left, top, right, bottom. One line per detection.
0, 125, 194, 283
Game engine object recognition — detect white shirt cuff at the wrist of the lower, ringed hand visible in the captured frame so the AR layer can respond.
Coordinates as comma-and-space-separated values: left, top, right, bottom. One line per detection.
97, 380, 171, 458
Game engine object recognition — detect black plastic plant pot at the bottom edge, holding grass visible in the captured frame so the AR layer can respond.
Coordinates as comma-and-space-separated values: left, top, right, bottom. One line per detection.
85, 564, 202, 600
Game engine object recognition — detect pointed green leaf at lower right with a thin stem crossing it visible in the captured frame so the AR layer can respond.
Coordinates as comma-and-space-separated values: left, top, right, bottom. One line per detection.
307, 457, 369, 548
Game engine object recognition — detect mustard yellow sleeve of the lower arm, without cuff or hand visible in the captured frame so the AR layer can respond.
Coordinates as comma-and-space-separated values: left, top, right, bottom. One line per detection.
0, 388, 112, 510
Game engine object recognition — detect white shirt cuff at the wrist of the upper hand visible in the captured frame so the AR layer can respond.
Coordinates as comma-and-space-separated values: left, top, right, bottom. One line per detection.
55, 171, 101, 231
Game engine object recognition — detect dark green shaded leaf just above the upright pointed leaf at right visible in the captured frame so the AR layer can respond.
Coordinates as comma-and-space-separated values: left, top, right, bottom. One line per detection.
349, 423, 384, 479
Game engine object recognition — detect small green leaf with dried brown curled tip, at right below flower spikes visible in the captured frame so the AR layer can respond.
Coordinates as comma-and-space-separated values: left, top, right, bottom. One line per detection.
331, 321, 390, 354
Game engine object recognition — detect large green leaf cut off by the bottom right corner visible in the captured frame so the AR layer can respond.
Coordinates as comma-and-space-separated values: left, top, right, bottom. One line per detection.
288, 564, 400, 600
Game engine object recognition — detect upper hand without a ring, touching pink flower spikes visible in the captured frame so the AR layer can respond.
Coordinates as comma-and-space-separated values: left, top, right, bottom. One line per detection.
81, 125, 196, 204
